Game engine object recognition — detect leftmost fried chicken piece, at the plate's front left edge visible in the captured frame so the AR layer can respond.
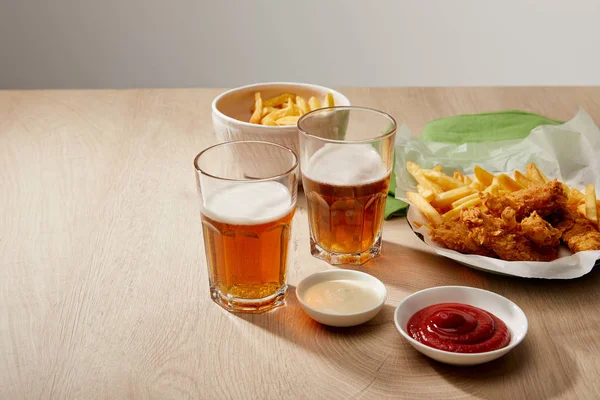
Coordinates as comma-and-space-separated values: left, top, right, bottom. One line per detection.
429, 216, 496, 257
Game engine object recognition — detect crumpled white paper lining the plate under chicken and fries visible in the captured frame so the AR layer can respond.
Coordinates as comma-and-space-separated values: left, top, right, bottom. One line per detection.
396, 109, 600, 279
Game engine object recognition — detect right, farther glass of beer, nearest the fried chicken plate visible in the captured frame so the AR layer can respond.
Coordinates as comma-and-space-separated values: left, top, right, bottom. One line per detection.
298, 107, 396, 264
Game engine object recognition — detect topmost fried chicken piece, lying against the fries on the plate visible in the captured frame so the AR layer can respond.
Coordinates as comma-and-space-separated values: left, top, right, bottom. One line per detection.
483, 179, 567, 222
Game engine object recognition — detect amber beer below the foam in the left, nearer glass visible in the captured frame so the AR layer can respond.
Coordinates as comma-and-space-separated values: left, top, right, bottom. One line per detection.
202, 210, 294, 300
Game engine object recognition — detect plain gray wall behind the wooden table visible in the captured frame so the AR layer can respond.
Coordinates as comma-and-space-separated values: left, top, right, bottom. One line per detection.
0, 0, 600, 89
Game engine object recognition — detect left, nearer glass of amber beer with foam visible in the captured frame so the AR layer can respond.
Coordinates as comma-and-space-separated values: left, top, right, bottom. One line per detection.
194, 141, 298, 312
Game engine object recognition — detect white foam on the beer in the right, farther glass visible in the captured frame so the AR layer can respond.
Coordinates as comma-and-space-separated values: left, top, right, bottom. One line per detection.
302, 143, 387, 186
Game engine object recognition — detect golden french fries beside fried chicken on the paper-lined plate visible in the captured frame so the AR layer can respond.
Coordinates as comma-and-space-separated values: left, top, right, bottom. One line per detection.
406, 161, 600, 228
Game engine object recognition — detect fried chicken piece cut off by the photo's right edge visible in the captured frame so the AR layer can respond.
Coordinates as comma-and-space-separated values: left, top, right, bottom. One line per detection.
558, 207, 600, 253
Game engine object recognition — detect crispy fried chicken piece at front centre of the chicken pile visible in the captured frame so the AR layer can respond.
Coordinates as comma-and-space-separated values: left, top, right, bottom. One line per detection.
461, 208, 558, 261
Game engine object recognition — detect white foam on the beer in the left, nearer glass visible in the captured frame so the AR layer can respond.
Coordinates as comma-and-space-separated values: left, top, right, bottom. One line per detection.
202, 181, 293, 225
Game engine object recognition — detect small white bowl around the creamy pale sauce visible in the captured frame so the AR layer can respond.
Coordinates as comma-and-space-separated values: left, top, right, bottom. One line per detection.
296, 269, 387, 327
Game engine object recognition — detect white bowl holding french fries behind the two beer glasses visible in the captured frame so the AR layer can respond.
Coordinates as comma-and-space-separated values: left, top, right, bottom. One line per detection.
212, 82, 350, 154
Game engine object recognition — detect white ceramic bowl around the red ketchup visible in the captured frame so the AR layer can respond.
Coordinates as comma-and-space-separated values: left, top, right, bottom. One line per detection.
394, 286, 528, 365
